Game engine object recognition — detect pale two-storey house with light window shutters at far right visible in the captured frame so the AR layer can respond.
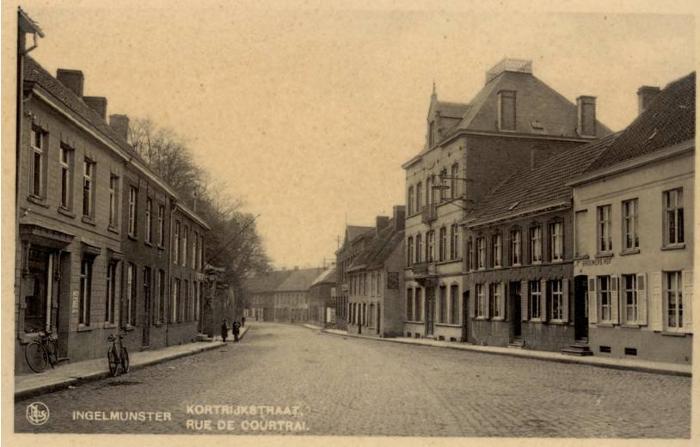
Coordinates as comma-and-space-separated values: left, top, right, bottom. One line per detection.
571, 73, 695, 363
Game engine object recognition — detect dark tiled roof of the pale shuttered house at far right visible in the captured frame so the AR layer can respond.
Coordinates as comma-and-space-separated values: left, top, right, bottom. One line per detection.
586, 72, 695, 172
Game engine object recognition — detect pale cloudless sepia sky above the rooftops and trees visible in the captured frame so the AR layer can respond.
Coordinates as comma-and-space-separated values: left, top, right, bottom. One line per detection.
15, 0, 695, 267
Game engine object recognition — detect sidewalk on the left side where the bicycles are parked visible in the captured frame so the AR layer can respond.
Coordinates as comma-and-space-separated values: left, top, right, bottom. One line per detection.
15, 326, 248, 400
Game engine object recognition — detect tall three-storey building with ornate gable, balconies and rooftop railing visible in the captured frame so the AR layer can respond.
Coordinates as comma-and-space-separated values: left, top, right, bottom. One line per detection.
402, 59, 610, 341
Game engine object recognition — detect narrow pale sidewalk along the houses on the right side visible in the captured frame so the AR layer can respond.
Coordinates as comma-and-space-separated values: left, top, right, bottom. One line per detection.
320, 325, 693, 377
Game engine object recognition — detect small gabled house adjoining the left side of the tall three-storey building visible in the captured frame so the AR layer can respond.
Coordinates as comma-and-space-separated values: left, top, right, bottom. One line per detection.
347, 206, 406, 337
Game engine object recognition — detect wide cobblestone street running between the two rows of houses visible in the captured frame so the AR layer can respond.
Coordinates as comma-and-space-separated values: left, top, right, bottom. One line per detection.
15, 323, 691, 438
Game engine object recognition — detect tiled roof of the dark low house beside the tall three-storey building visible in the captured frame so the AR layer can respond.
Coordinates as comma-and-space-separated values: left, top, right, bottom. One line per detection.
470, 133, 620, 225
